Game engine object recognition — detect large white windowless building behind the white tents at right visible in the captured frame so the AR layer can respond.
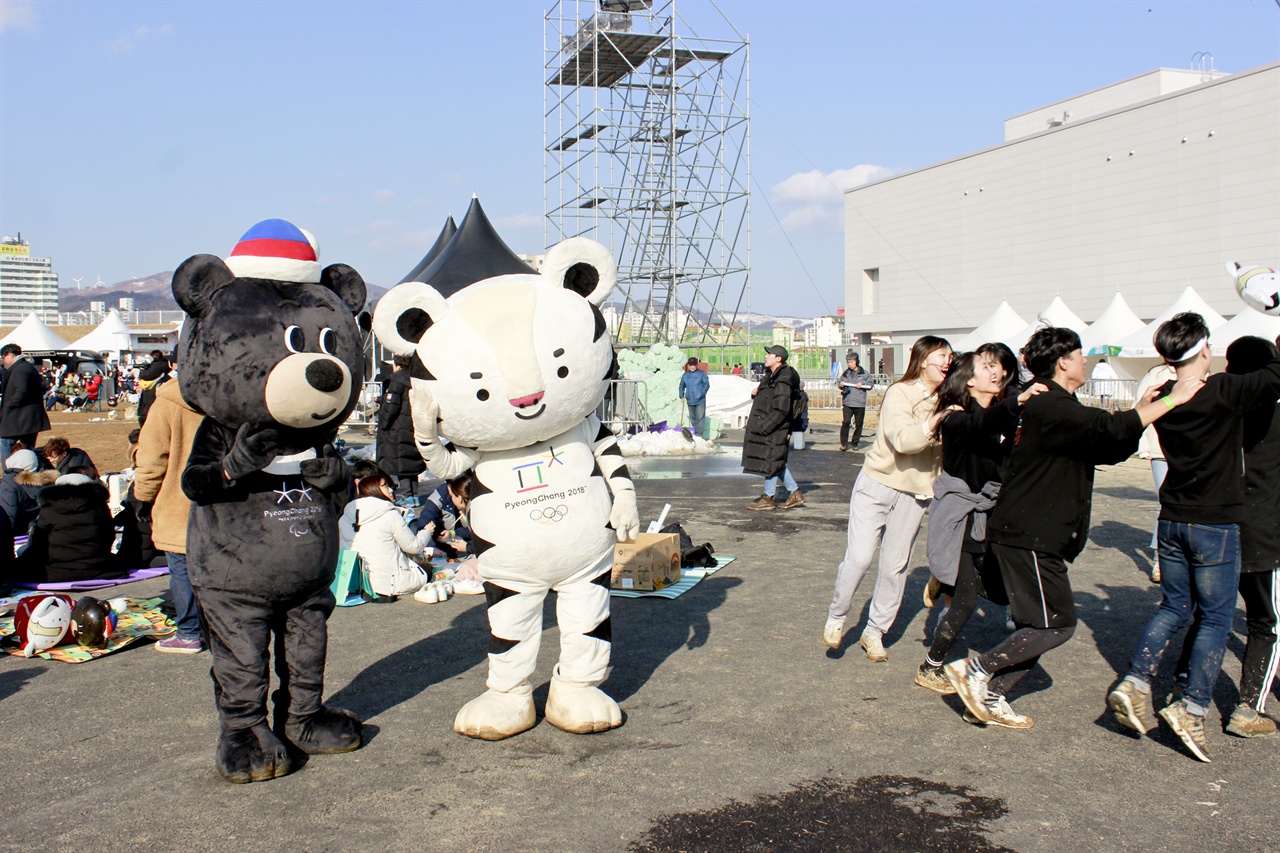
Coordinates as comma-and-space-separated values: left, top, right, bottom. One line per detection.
845, 63, 1280, 345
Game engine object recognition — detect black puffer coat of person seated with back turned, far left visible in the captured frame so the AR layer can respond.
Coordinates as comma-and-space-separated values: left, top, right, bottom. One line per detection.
14, 467, 125, 583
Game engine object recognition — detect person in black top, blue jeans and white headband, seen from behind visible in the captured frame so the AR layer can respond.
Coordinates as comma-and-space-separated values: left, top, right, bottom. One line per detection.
1107, 313, 1280, 762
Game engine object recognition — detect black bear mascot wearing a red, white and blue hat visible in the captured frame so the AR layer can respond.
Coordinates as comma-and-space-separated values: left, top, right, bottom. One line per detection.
173, 219, 365, 783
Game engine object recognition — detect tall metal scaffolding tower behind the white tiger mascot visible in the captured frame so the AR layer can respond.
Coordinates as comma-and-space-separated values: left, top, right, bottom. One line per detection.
543, 0, 750, 348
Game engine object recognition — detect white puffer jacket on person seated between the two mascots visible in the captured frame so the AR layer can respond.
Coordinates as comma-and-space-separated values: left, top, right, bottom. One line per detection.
340, 497, 434, 596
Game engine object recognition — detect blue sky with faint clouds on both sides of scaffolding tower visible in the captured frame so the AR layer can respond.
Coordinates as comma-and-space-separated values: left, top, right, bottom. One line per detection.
0, 0, 1280, 316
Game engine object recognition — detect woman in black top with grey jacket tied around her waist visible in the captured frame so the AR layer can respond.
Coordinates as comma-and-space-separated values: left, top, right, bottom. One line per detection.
915, 345, 1048, 694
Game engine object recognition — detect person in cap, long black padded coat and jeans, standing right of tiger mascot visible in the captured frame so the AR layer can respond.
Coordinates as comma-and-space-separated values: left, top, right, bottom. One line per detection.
742, 345, 804, 510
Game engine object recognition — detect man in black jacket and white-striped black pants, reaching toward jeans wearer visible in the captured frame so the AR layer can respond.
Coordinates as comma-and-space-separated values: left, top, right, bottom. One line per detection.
943, 327, 1204, 729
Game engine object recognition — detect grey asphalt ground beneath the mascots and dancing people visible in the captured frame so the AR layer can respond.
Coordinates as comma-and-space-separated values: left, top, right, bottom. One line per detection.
0, 427, 1280, 852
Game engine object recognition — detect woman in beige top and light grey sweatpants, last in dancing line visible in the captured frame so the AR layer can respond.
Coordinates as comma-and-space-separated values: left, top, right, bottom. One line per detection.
822, 334, 951, 661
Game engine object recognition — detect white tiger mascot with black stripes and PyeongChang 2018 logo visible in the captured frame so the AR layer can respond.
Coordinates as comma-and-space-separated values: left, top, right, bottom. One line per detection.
374, 237, 640, 740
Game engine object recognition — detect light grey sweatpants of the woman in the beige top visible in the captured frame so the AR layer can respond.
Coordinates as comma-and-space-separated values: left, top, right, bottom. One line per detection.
828, 471, 929, 637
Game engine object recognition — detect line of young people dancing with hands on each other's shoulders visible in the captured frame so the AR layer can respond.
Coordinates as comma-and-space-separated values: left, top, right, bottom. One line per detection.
793, 314, 1280, 762
